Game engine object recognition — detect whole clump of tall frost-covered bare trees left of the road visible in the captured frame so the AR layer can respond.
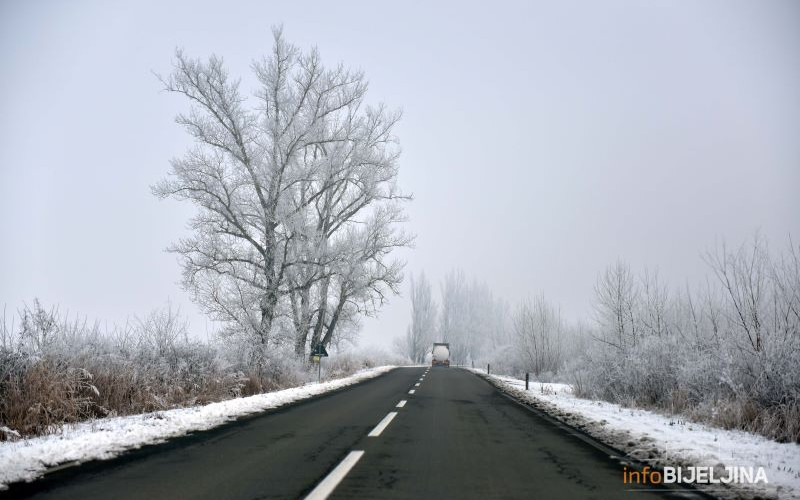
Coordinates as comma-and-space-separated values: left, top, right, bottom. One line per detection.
153, 29, 411, 356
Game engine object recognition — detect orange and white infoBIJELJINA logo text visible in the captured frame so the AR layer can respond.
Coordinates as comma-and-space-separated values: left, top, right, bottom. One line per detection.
622, 466, 769, 485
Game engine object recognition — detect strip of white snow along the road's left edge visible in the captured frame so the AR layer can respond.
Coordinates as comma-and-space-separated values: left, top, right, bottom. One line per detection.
0, 366, 395, 490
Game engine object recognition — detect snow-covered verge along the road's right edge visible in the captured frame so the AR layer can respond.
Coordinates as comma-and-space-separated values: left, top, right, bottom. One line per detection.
472, 369, 800, 499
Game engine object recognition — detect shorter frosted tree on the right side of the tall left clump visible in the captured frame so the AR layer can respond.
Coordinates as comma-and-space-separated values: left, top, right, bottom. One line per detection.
290, 87, 411, 354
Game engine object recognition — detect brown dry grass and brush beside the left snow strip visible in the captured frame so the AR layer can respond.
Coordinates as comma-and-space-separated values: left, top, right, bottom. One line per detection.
0, 350, 376, 440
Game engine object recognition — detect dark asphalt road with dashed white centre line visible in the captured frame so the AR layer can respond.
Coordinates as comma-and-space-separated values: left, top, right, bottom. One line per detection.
6, 368, 708, 500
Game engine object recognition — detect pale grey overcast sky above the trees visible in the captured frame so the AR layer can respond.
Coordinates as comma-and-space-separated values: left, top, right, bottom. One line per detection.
0, 0, 800, 345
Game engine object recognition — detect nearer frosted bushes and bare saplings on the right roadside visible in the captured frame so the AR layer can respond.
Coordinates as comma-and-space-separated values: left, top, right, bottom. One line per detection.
567, 238, 800, 441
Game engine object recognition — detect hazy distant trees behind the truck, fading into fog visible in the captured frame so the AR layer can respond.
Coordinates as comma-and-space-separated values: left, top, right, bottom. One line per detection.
398, 270, 585, 378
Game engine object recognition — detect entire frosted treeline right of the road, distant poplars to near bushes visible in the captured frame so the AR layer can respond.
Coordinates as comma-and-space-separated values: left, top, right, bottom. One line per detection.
402, 237, 800, 442
